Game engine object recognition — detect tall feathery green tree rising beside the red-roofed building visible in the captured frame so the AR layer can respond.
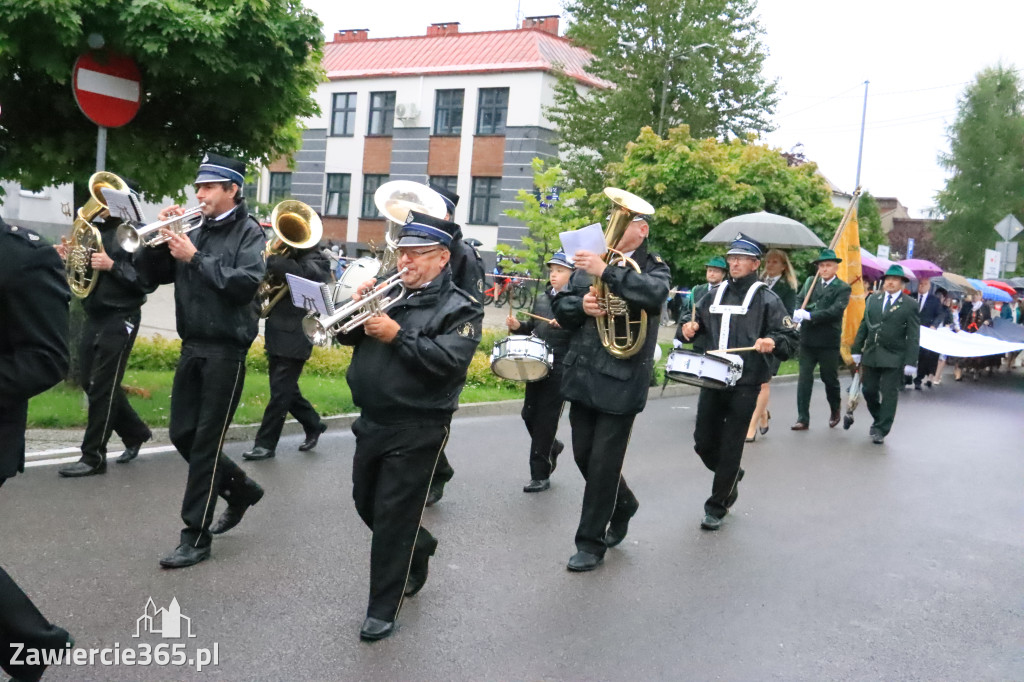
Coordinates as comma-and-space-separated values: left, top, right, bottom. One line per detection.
548, 0, 778, 194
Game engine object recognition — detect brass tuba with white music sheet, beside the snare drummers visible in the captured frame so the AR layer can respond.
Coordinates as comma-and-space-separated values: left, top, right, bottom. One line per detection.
594, 187, 654, 359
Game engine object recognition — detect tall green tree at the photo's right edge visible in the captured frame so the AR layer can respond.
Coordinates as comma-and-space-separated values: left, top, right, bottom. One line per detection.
934, 65, 1024, 272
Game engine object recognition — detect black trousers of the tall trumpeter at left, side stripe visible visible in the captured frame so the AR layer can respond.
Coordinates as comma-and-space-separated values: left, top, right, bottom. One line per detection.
170, 349, 260, 547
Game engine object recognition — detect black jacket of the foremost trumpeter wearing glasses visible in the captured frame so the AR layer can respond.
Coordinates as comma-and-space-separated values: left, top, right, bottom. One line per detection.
338, 267, 483, 424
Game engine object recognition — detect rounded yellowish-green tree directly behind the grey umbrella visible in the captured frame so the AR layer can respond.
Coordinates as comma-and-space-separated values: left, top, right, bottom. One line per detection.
609, 126, 843, 285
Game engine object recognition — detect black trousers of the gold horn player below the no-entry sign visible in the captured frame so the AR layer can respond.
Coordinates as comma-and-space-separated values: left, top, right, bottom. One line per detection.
79, 310, 153, 467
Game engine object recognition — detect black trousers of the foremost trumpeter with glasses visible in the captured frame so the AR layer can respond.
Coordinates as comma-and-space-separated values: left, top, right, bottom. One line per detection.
352, 417, 451, 623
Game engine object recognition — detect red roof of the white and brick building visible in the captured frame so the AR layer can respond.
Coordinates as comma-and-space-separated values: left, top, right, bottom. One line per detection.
324, 29, 610, 87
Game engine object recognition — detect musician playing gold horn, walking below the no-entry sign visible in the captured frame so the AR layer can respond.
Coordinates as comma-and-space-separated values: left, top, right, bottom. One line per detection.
56, 183, 154, 477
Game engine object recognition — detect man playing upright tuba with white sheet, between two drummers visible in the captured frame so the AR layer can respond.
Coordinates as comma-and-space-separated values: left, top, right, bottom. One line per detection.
554, 215, 671, 572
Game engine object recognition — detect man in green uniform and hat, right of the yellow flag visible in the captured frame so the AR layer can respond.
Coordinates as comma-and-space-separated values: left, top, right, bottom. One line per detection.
852, 265, 921, 445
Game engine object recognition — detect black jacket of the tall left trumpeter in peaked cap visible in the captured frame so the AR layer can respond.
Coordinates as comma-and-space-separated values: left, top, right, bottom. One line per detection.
135, 201, 266, 357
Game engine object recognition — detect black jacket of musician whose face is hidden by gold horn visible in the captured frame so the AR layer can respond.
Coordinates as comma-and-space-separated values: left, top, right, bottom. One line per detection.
264, 246, 331, 359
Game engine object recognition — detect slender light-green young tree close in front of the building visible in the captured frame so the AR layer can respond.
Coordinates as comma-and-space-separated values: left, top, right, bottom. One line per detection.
507, 159, 591, 273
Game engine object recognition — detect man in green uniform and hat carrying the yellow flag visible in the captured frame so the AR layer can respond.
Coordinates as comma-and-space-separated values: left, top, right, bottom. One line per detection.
792, 249, 850, 431
